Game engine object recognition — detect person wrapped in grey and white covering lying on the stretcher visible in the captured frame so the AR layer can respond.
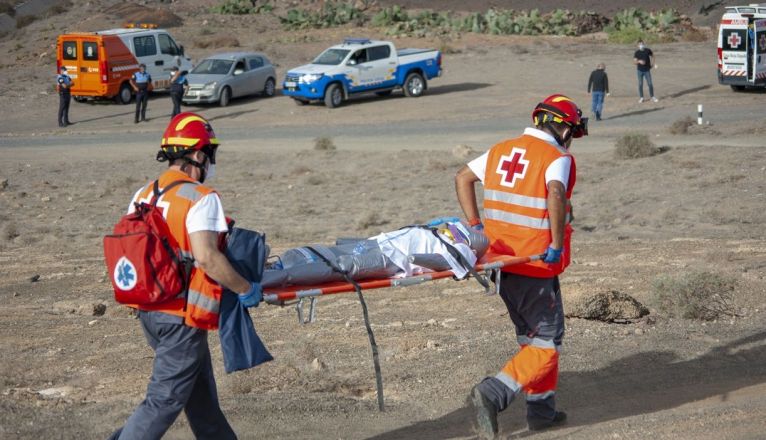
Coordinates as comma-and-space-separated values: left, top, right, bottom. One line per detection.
261, 218, 489, 288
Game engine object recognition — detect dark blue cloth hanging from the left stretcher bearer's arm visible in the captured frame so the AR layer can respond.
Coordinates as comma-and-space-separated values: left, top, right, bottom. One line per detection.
218, 228, 274, 373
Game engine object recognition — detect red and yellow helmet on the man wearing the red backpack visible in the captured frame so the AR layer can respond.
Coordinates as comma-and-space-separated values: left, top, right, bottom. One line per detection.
157, 112, 218, 163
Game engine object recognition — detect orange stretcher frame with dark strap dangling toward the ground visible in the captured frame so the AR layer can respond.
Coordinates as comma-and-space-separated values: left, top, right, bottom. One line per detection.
263, 254, 543, 411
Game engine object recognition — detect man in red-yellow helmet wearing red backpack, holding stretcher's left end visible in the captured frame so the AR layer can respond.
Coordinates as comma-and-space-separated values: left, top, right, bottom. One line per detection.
110, 113, 262, 440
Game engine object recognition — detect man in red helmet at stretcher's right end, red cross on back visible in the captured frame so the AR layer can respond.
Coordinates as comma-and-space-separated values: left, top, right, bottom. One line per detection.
455, 95, 588, 438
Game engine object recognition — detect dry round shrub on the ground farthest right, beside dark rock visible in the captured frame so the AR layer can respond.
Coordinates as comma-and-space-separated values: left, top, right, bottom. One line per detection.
652, 272, 737, 321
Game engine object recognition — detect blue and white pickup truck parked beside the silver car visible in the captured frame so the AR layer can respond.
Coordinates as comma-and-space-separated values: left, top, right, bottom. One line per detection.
282, 39, 442, 108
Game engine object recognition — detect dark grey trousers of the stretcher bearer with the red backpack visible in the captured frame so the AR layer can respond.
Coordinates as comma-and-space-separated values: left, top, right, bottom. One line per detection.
109, 311, 237, 440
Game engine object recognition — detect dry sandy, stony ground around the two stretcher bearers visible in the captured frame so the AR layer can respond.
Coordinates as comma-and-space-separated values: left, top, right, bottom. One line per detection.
0, 3, 766, 439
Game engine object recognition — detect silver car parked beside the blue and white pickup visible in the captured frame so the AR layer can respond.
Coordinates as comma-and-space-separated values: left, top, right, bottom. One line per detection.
182, 52, 277, 107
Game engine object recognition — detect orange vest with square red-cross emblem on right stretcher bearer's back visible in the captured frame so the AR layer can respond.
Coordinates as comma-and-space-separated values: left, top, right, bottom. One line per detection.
484, 135, 575, 278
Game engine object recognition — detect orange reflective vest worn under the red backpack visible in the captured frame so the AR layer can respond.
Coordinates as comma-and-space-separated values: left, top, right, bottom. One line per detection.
131, 170, 223, 330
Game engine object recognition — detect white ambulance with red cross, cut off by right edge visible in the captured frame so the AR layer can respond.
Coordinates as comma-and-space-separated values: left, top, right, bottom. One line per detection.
718, 3, 766, 90
